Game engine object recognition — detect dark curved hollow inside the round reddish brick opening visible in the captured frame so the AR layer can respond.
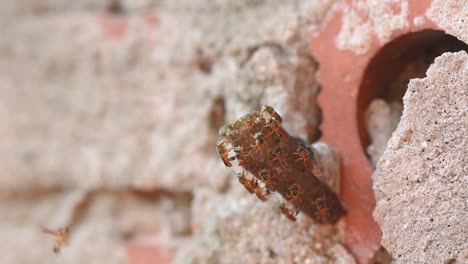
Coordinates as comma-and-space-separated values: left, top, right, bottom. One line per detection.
357, 30, 468, 164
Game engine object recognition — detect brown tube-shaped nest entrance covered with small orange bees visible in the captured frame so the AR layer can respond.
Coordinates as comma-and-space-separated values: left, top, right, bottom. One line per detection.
217, 106, 345, 224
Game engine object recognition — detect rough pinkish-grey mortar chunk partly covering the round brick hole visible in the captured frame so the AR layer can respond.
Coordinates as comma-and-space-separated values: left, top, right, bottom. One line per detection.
373, 52, 468, 263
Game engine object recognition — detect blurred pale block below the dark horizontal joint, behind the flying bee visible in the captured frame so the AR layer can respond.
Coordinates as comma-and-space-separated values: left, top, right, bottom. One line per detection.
0, 191, 190, 263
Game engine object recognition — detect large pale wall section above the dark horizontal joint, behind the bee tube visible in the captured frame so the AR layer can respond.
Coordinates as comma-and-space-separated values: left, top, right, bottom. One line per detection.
0, 2, 329, 194
